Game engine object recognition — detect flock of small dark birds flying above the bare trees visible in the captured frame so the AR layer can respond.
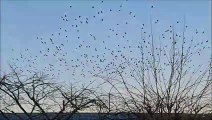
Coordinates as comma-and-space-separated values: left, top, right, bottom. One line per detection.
13, 1, 209, 81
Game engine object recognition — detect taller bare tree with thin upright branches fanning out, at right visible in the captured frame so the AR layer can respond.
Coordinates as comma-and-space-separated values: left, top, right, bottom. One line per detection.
95, 18, 212, 120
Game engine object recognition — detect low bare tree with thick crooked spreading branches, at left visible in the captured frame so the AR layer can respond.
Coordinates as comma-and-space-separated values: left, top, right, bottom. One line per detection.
0, 66, 104, 120
